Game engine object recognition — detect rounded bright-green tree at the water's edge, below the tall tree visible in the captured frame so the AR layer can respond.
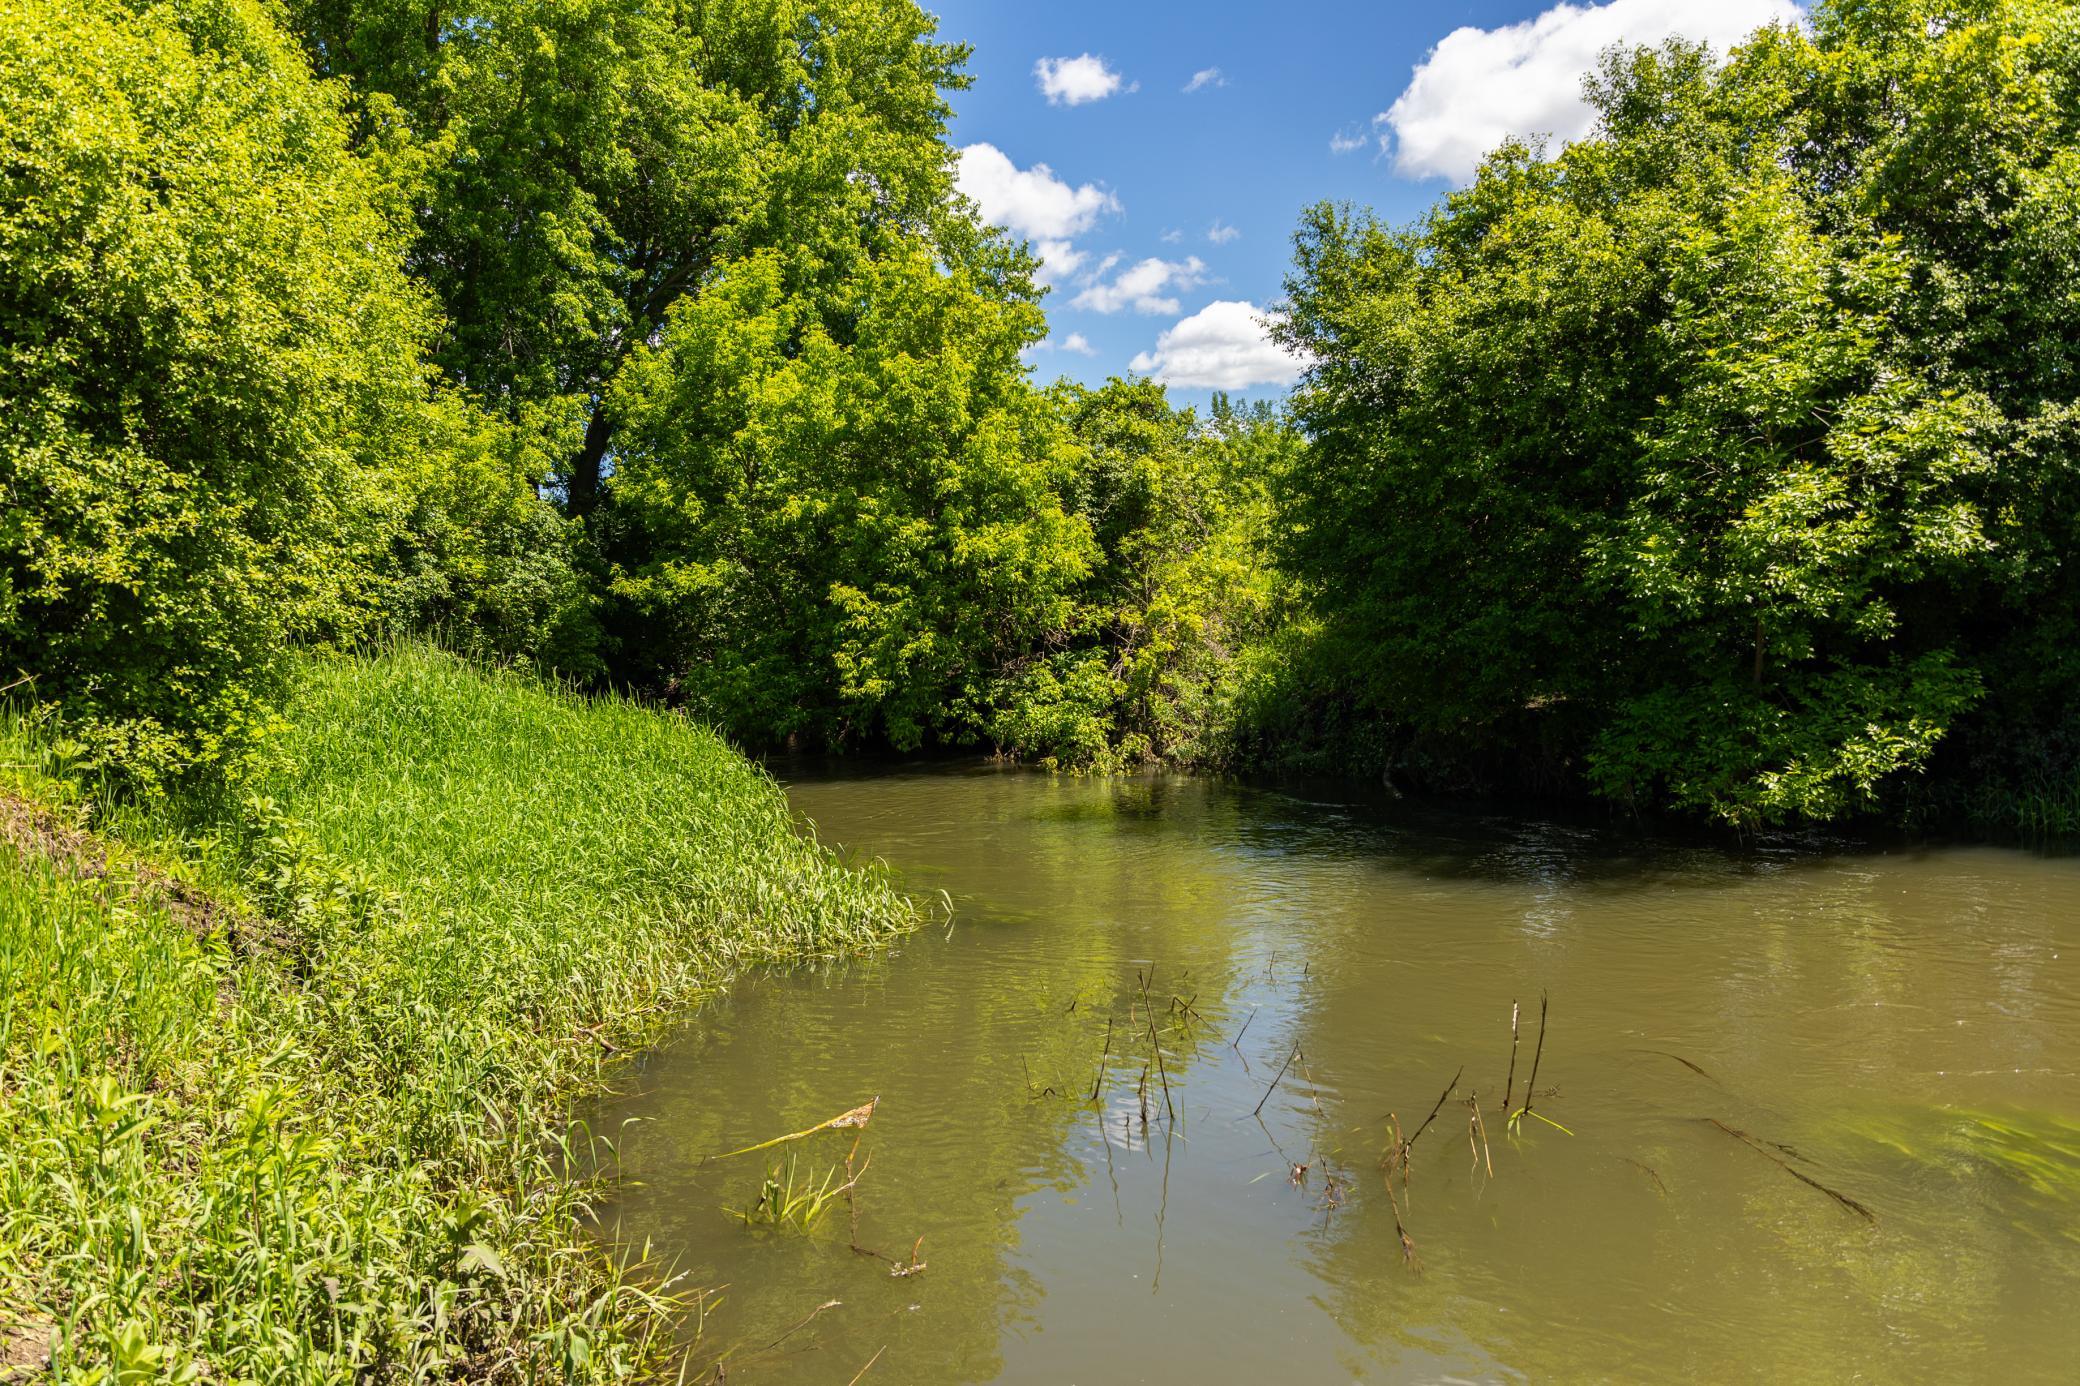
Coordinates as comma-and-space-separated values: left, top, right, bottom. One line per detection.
601, 248, 1090, 747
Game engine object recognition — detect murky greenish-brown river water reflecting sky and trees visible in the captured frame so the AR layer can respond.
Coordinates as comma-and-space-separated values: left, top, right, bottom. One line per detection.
607, 766, 2080, 1382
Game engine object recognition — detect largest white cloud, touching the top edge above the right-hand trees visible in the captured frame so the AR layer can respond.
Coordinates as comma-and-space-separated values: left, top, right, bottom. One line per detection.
1381, 0, 1799, 183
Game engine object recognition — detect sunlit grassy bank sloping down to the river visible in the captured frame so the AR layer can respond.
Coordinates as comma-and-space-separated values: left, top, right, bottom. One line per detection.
0, 649, 913, 1382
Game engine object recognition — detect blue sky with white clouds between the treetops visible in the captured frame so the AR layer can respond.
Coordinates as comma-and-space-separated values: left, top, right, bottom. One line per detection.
944, 0, 1797, 402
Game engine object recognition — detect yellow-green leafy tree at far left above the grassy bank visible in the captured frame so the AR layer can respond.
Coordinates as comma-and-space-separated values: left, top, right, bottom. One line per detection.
0, 0, 490, 778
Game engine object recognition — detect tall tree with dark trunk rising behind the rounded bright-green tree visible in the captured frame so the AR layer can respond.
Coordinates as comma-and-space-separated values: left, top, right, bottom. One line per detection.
291, 0, 965, 514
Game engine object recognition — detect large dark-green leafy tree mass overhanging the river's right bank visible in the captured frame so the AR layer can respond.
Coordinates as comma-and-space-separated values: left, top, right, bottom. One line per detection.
1283, 2, 2080, 822
